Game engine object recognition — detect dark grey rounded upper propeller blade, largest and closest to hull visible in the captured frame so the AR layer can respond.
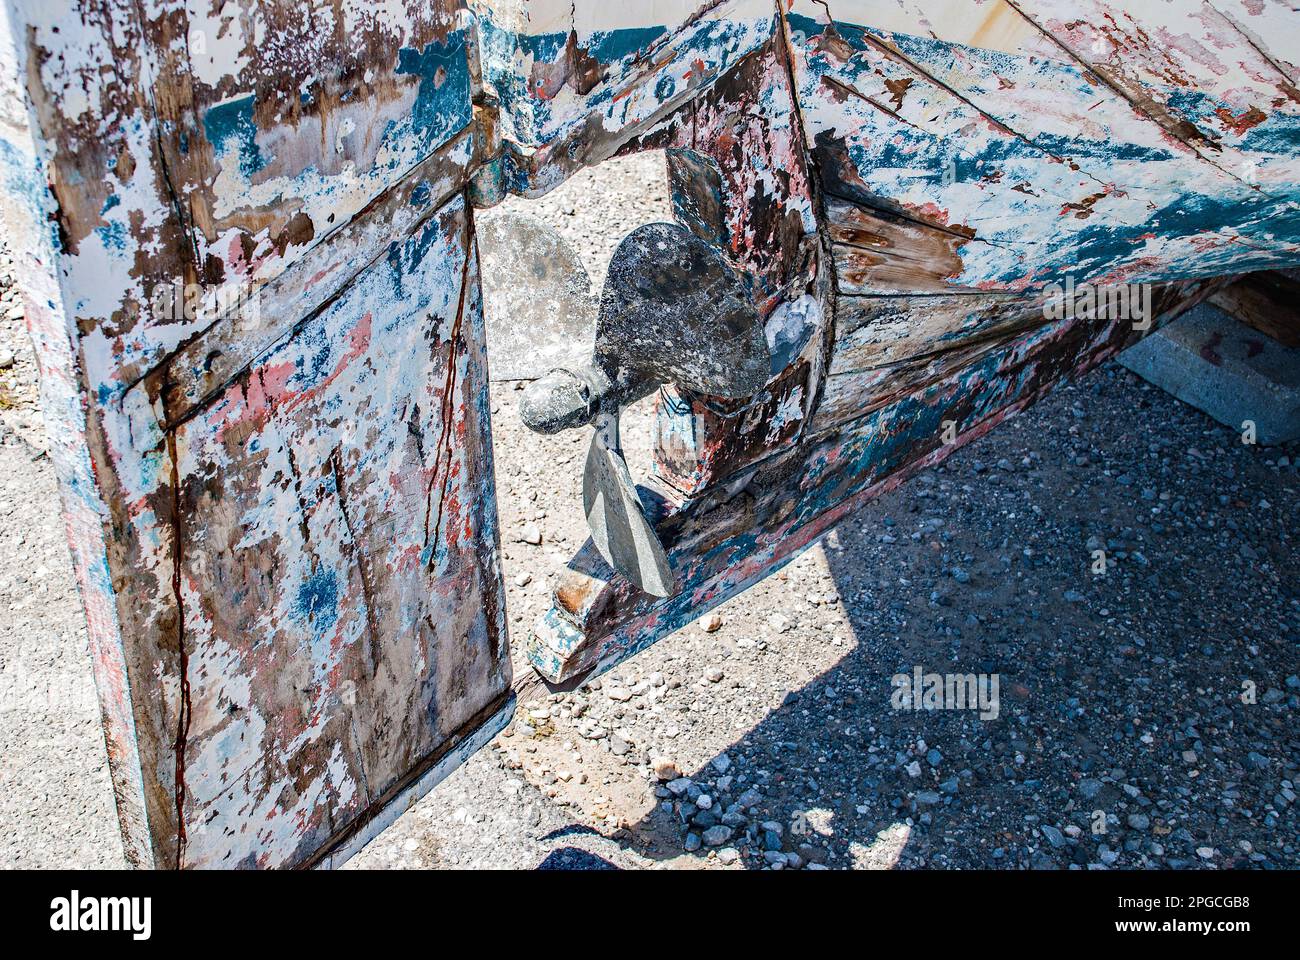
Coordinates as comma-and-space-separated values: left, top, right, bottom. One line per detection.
595, 224, 771, 397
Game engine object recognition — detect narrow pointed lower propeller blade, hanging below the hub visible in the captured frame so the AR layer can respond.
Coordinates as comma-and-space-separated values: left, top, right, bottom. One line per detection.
582, 414, 675, 597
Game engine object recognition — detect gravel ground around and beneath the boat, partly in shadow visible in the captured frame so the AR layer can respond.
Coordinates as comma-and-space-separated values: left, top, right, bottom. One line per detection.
0, 155, 1300, 869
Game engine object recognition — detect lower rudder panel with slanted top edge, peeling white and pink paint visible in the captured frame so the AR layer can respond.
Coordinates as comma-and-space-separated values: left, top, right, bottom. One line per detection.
163, 200, 510, 866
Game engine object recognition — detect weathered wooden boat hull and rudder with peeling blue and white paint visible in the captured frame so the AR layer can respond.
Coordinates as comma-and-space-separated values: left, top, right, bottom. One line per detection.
0, 0, 1300, 866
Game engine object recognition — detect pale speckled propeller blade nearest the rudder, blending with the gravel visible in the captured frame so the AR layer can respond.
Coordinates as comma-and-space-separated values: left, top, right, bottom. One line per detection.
476, 212, 597, 380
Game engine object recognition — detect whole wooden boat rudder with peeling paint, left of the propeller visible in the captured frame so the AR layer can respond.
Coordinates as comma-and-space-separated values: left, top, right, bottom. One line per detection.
0, 0, 508, 866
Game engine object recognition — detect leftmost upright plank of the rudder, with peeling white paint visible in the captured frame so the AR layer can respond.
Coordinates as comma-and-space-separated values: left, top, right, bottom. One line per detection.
0, 1, 185, 866
